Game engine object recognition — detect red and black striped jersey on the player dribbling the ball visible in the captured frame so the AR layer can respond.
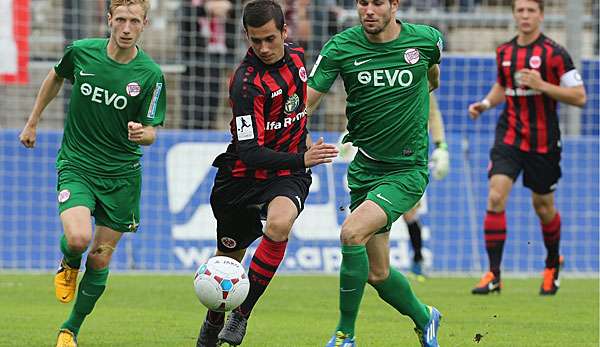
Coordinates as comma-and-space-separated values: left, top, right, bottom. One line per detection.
213, 43, 308, 179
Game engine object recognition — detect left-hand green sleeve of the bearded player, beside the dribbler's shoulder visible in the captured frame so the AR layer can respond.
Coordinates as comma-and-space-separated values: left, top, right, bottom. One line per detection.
308, 37, 340, 93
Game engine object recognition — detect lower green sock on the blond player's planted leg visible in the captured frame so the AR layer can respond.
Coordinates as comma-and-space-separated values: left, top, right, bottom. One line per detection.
60, 267, 108, 335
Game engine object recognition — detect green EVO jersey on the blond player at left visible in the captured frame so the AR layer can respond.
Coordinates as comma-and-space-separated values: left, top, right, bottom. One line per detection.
54, 39, 166, 177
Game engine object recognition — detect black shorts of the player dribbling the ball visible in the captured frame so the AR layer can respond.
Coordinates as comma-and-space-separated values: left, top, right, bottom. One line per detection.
210, 171, 312, 252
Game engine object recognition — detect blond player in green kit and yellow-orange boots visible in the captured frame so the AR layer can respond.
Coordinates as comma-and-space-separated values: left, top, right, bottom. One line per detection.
20, 0, 166, 347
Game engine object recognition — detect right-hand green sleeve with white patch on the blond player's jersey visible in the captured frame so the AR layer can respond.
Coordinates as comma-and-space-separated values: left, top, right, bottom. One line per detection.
139, 72, 167, 126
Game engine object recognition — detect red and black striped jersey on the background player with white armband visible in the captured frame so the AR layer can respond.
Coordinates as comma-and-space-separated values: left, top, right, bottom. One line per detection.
496, 34, 575, 153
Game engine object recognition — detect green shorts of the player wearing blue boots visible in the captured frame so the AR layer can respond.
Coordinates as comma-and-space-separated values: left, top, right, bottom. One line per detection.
348, 151, 429, 234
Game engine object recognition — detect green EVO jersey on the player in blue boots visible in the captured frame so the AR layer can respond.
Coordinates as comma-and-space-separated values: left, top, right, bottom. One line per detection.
308, 23, 443, 166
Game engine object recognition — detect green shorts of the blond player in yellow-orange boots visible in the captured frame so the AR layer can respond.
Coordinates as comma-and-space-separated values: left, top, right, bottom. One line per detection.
56, 169, 142, 232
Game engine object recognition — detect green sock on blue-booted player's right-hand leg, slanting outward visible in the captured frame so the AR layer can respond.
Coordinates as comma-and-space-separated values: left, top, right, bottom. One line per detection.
373, 267, 431, 329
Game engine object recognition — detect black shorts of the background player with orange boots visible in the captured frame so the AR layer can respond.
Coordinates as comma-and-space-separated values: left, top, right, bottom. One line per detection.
488, 145, 562, 194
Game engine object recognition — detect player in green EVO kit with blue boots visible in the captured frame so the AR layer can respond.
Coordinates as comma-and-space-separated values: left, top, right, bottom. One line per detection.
307, 0, 443, 347
